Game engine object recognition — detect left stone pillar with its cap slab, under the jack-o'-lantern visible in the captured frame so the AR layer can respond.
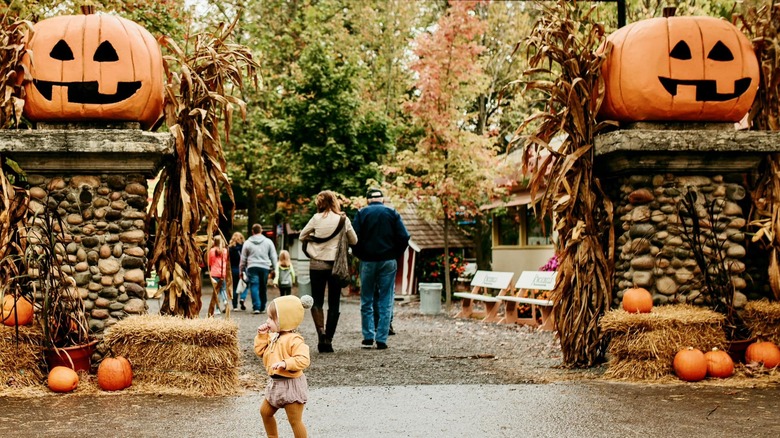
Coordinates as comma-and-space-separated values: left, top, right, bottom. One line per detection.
0, 124, 173, 352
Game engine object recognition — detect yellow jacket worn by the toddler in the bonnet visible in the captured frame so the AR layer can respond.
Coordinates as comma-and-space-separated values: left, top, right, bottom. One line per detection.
255, 332, 311, 378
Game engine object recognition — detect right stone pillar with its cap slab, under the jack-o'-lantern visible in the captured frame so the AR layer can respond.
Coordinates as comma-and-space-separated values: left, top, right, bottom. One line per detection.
595, 123, 780, 308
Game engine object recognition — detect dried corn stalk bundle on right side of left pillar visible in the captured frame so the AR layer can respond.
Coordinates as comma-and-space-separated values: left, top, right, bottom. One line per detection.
150, 19, 256, 318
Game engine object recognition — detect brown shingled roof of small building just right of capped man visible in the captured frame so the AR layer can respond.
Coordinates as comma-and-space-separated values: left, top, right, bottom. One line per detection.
398, 204, 474, 251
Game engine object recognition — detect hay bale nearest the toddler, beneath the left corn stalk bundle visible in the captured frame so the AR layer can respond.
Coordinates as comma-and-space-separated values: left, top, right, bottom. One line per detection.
103, 315, 240, 395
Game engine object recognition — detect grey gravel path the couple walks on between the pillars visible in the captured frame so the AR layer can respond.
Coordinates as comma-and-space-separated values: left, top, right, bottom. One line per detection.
222, 291, 601, 390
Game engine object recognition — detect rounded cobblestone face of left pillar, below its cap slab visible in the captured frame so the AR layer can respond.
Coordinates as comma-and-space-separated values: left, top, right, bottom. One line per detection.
28, 174, 148, 334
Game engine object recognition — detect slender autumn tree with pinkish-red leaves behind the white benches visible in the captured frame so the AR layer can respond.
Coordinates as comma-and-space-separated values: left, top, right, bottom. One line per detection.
385, 2, 495, 306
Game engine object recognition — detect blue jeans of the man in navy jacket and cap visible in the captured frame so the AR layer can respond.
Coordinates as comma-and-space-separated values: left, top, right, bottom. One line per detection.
360, 260, 398, 344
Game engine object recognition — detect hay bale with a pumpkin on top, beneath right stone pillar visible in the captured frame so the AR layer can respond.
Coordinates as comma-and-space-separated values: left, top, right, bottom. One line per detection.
600, 304, 726, 380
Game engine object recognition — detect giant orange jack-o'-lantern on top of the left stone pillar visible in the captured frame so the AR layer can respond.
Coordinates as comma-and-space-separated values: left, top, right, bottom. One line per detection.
24, 14, 164, 129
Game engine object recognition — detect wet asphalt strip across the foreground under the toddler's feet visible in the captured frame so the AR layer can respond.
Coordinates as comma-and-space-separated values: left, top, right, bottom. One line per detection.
0, 382, 780, 438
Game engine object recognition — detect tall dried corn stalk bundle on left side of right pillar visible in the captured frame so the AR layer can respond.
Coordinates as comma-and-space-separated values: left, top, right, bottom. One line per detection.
520, 1, 615, 366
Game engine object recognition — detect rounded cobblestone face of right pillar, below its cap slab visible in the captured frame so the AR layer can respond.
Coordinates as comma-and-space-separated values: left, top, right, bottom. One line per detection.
613, 173, 766, 308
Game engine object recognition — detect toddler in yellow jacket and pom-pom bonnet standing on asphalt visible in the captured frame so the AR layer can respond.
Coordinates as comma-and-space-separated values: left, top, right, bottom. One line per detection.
255, 295, 314, 438
